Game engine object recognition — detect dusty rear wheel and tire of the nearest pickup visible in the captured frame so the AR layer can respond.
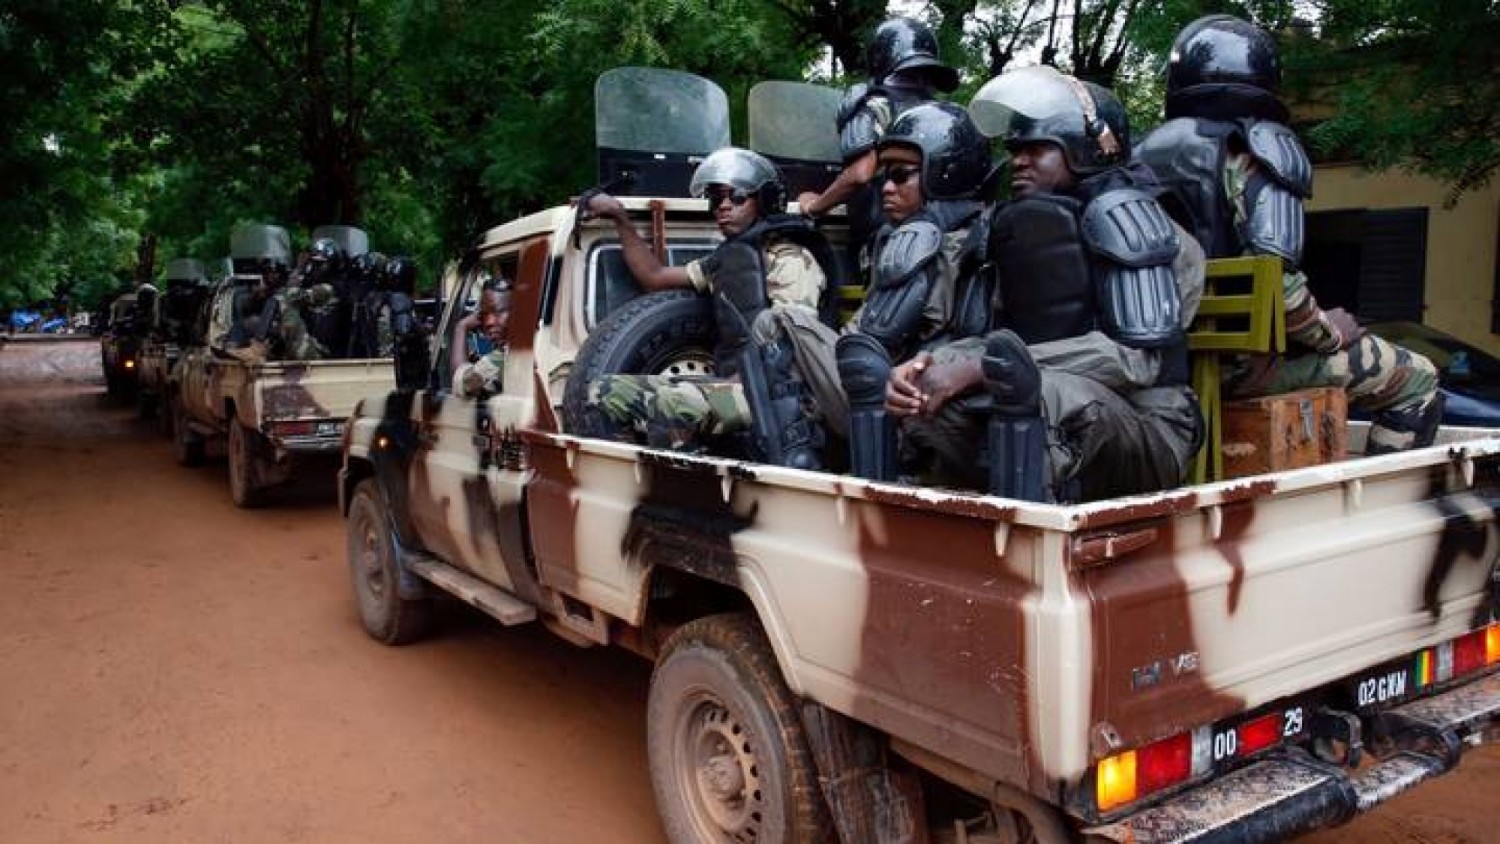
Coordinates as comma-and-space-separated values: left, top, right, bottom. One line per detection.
647, 613, 834, 844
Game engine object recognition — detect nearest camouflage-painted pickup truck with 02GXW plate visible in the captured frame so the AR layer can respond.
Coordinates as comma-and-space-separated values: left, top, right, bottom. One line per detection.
339, 69, 1500, 844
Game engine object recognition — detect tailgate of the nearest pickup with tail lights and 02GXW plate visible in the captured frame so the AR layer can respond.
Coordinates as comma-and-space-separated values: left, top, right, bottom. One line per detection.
1053, 442, 1500, 832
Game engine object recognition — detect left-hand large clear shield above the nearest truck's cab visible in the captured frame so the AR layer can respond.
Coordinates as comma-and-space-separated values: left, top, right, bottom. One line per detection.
594, 67, 729, 156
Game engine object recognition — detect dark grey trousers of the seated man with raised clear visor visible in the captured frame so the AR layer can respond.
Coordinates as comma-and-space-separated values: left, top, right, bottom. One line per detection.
900, 342, 1202, 501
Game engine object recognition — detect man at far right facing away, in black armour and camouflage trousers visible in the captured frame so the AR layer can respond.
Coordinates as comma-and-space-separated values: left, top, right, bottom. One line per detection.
1137, 15, 1443, 454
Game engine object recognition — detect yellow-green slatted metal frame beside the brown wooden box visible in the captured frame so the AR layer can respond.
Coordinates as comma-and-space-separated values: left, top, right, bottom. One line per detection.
1188, 255, 1287, 484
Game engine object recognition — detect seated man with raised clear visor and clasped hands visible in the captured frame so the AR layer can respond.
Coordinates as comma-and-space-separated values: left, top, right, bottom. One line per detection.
885, 67, 1202, 501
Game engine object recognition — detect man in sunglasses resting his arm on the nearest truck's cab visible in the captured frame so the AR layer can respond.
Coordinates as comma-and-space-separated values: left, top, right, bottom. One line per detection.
587, 147, 846, 469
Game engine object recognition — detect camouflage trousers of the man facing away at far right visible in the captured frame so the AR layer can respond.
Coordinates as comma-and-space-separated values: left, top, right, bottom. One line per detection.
1226, 334, 1437, 451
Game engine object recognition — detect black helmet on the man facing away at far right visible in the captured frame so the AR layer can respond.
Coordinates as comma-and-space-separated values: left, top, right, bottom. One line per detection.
1167, 15, 1287, 123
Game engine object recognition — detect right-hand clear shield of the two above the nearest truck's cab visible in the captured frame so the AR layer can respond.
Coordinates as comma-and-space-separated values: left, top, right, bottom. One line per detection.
750, 82, 843, 198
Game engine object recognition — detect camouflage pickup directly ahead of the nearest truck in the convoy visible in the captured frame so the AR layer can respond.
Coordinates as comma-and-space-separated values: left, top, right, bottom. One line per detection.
167, 226, 395, 507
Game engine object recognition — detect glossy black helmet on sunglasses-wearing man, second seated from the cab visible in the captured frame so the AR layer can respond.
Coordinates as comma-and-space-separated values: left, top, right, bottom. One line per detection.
881, 102, 992, 199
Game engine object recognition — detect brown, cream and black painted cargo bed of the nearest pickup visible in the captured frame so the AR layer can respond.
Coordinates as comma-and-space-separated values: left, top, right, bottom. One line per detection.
524, 424, 1500, 822
